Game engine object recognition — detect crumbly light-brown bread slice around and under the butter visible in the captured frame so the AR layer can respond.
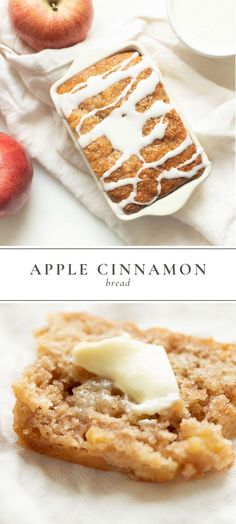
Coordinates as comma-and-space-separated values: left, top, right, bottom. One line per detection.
14, 313, 236, 482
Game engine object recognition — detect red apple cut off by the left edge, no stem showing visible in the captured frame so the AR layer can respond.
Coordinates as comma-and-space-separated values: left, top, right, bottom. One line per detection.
0, 132, 33, 217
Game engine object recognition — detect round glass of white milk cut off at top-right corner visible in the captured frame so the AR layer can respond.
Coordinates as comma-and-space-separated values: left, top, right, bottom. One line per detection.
168, 0, 236, 57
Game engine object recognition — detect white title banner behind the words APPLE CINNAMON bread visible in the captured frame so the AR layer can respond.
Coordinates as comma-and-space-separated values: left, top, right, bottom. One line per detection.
0, 248, 236, 301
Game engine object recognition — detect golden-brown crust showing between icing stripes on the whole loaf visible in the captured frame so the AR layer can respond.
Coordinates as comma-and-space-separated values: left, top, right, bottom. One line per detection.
57, 51, 208, 215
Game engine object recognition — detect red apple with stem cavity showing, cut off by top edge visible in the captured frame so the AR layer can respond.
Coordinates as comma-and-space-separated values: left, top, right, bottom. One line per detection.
9, 0, 93, 51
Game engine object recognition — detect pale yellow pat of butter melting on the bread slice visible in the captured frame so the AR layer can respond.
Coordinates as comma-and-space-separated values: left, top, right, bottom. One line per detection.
72, 333, 180, 415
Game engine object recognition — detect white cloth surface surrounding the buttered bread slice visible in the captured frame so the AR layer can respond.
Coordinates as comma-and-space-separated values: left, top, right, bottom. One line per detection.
0, 303, 236, 524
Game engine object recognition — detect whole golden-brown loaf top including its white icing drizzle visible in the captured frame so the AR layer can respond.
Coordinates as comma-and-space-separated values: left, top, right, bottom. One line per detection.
57, 51, 208, 214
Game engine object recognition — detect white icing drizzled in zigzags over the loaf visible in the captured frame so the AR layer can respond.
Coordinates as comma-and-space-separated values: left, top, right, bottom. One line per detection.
60, 52, 209, 210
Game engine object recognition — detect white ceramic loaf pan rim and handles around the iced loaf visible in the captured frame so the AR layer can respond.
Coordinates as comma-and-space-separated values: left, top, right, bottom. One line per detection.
51, 41, 211, 221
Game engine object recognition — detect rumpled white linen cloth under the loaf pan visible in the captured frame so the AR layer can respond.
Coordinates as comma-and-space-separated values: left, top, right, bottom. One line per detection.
0, 0, 236, 245
